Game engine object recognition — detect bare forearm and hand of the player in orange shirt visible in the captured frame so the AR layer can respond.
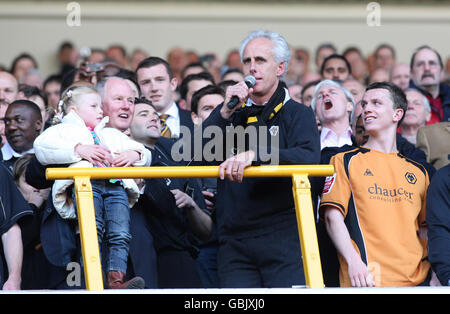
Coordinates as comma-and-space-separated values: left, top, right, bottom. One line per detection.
323, 206, 375, 287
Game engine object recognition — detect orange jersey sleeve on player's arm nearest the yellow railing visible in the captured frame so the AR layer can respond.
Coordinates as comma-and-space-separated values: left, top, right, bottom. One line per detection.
319, 154, 351, 219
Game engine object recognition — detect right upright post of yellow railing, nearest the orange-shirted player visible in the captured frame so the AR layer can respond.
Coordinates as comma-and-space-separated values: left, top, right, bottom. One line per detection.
292, 174, 324, 288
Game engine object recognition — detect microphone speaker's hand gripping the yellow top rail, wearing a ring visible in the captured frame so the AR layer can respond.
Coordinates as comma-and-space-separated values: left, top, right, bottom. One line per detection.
219, 150, 255, 182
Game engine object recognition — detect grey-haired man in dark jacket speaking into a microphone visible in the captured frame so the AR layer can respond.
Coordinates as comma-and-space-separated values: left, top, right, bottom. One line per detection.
202, 31, 320, 288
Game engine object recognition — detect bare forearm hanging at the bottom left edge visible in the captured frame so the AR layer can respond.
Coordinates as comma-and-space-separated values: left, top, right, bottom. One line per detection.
2, 224, 23, 290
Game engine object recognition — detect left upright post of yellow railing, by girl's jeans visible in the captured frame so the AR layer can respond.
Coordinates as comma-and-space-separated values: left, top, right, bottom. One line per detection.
74, 177, 103, 290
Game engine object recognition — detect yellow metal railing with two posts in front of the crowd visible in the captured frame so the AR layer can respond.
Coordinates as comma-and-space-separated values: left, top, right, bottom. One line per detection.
46, 165, 334, 290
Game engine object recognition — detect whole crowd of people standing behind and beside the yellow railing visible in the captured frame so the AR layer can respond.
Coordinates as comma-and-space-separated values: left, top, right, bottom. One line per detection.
0, 30, 450, 290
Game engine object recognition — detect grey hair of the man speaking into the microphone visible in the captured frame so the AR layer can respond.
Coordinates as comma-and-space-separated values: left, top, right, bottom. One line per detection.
239, 30, 291, 76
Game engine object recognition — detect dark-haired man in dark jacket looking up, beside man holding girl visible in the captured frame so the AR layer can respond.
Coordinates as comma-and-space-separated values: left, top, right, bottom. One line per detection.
126, 99, 212, 288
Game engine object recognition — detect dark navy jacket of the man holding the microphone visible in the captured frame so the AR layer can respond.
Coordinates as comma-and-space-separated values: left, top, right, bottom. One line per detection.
202, 99, 320, 241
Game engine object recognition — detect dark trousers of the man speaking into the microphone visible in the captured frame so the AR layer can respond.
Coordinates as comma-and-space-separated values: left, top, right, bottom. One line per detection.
218, 225, 305, 288
